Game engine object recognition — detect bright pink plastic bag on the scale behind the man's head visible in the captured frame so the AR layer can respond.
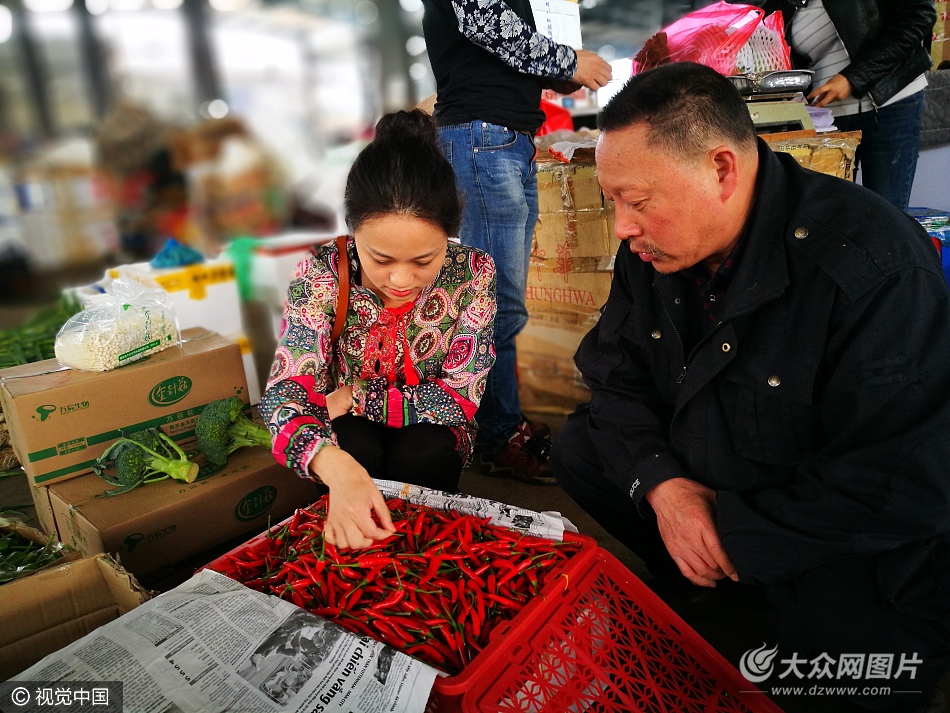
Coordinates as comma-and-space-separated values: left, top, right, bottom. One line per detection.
633, 2, 765, 76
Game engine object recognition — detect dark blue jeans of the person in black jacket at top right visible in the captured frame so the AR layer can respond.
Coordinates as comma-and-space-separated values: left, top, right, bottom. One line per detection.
835, 92, 924, 210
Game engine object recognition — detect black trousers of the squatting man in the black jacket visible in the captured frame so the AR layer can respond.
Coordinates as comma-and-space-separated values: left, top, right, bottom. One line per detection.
551, 408, 950, 712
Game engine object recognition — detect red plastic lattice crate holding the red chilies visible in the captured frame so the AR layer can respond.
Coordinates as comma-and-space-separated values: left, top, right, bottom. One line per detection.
206, 518, 782, 713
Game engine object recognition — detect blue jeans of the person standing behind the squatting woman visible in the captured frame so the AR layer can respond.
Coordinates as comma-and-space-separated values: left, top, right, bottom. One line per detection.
439, 121, 538, 453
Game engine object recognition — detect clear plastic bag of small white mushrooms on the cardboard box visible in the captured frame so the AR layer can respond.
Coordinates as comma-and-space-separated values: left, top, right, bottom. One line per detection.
55, 273, 181, 371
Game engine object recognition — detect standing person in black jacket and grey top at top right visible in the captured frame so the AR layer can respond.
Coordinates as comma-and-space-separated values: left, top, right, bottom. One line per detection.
762, 0, 936, 210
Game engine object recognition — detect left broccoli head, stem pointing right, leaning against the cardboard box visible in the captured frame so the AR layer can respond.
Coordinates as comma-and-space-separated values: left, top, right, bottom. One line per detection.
92, 428, 198, 495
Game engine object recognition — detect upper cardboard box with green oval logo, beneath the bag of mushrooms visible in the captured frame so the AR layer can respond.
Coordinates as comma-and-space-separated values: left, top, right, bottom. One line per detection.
0, 329, 248, 486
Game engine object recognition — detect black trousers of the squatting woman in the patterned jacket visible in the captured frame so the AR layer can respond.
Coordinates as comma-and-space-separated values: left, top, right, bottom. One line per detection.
332, 414, 462, 492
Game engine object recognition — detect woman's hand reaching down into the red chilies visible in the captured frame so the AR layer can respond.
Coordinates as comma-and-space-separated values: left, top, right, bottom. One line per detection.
310, 446, 396, 549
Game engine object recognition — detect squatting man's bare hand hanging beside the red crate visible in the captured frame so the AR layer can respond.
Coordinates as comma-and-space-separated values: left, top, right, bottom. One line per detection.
645, 478, 739, 587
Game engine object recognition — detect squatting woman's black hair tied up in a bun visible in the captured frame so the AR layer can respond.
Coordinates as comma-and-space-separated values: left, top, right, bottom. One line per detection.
344, 109, 462, 236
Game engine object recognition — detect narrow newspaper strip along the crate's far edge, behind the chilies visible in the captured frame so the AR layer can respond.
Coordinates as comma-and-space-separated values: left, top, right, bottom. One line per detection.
373, 480, 577, 542
